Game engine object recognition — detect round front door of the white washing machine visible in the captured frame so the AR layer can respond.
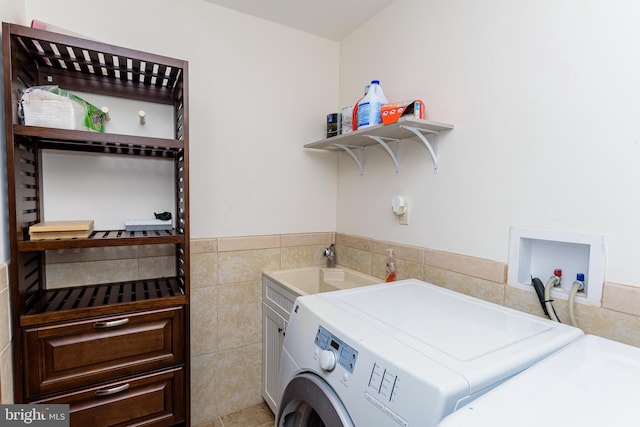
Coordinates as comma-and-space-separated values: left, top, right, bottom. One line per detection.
276, 372, 354, 427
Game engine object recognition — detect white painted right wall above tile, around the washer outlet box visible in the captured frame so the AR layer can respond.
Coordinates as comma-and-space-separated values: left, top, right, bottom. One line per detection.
337, 0, 640, 285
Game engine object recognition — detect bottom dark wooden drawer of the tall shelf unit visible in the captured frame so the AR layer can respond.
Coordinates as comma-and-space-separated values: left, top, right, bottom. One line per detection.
30, 368, 185, 427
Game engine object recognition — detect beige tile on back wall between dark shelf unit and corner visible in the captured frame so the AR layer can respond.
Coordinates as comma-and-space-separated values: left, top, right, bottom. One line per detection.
191, 233, 334, 427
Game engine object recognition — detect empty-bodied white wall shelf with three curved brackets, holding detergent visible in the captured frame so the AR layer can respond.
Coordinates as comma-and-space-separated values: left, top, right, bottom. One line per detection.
304, 117, 453, 175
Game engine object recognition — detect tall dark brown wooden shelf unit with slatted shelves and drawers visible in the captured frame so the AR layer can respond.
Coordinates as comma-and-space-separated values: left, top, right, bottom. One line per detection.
2, 23, 189, 426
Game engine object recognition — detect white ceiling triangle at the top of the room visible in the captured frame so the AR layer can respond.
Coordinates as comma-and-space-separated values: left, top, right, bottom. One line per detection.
206, 0, 395, 41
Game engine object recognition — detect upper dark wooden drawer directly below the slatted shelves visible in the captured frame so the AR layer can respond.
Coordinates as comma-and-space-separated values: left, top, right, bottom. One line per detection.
24, 307, 185, 399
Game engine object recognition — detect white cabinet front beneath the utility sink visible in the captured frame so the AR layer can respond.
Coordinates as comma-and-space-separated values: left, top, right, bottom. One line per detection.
262, 275, 297, 413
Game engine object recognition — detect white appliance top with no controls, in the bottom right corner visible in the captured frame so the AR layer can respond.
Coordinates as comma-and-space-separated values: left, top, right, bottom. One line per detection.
440, 335, 640, 427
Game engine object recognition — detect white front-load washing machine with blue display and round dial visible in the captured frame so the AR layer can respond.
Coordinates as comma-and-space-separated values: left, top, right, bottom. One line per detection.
276, 279, 583, 427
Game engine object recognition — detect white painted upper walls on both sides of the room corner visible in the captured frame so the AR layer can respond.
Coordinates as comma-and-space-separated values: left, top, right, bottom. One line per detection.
13, 0, 640, 285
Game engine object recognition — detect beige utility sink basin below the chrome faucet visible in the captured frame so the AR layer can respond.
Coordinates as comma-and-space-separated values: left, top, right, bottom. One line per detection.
264, 266, 384, 296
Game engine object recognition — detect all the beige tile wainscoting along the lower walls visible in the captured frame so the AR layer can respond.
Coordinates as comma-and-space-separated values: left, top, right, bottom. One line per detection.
0, 232, 640, 427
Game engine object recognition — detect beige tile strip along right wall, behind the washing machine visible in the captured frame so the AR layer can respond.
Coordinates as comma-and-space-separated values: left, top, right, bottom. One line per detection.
336, 234, 640, 347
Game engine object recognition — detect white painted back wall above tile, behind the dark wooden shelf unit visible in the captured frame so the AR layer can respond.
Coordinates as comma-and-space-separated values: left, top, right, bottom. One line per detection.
20, 0, 339, 238
